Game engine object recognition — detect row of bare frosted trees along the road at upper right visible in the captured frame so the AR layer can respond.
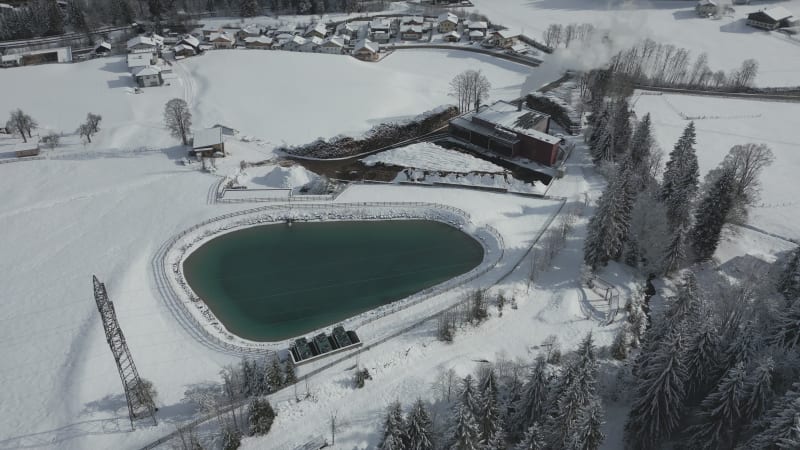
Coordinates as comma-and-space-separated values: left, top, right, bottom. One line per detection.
608, 39, 758, 90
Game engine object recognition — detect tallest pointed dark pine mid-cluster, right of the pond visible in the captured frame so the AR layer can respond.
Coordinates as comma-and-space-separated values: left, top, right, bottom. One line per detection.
661, 122, 700, 230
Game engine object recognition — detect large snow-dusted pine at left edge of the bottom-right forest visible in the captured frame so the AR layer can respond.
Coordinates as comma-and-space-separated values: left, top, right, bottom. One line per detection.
625, 333, 686, 448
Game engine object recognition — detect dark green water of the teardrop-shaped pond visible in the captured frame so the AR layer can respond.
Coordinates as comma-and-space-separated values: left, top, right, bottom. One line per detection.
183, 220, 483, 341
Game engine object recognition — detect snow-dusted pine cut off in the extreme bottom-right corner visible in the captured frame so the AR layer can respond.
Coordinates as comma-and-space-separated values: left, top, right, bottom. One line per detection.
745, 383, 800, 449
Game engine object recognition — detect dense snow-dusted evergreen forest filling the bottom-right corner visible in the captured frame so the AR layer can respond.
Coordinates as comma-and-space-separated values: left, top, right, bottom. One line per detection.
623, 249, 800, 450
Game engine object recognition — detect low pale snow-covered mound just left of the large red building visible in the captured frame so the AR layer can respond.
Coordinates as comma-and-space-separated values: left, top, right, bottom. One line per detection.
361, 142, 505, 173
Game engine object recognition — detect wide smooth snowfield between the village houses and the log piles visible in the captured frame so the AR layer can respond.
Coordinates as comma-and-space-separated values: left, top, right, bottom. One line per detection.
180, 50, 552, 145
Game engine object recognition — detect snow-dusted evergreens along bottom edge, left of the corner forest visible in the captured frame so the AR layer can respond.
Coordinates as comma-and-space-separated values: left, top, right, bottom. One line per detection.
378, 334, 604, 450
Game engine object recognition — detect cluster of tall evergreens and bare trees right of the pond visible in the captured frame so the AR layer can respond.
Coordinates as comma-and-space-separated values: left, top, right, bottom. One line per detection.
584, 92, 774, 274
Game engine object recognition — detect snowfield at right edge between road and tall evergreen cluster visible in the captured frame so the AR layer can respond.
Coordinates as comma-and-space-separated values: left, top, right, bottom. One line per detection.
633, 89, 800, 239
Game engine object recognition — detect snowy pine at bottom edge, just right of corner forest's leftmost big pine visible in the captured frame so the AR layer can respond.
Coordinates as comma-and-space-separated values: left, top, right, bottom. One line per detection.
688, 363, 747, 450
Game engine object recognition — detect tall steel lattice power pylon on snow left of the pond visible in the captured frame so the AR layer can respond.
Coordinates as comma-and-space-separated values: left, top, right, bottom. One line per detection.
92, 275, 157, 428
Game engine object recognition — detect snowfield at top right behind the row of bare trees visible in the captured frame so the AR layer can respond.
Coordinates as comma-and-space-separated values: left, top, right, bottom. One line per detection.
473, 0, 800, 86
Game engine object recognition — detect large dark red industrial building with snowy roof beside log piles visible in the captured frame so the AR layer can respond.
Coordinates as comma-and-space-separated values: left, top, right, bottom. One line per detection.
450, 101, 561, 166
